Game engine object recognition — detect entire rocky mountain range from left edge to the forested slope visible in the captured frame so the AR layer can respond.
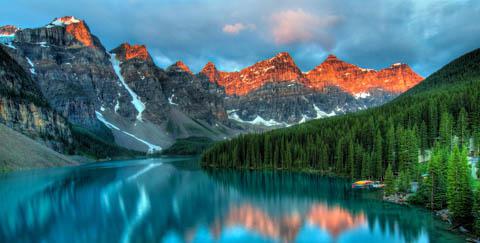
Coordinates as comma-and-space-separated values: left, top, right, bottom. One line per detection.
0, 16, 423, 158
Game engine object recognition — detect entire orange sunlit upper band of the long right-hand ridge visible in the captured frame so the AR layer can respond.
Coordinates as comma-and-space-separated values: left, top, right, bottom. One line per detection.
201, 52, 423, 96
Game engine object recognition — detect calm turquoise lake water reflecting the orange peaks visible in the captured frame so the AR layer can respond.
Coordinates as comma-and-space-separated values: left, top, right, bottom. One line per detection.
0, 158, 464, 243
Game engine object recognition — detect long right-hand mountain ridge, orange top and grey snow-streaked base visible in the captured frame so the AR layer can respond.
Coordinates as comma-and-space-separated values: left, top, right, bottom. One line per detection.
200, 53, 422, 126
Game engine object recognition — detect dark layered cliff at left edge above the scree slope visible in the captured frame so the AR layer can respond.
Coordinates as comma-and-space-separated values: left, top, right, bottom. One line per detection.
0, 46, 73, 152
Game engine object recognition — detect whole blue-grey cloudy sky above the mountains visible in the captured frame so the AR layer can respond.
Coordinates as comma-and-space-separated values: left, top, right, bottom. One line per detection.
0, 0, 480, 76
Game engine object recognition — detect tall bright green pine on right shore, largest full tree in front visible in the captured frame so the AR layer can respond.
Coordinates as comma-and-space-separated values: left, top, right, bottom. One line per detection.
447, 146, 473, 224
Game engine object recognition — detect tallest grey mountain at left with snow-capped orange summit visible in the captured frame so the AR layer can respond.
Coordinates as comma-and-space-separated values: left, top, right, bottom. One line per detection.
0, 17, 140, 139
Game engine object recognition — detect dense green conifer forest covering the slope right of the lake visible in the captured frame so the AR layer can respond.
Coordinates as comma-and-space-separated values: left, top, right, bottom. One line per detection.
201, 49, 480, 233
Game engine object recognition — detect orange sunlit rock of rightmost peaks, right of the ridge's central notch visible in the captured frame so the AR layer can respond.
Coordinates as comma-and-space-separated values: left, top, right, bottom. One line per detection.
306, 55, 423, 95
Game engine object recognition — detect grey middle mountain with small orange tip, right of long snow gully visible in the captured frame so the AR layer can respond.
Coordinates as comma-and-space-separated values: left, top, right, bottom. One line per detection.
105, 43, 231, 150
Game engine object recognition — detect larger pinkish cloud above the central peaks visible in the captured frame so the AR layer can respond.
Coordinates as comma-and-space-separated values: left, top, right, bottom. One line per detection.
271, 9, 340, 49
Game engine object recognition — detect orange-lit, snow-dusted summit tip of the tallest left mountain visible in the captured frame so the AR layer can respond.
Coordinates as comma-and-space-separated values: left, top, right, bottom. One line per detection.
47, 16, 93, 47
